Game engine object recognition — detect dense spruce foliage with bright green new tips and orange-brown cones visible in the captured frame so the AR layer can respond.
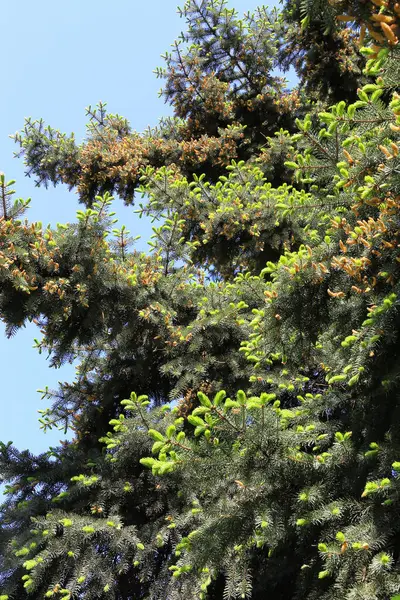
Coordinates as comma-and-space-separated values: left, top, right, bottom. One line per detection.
0, 0, 400, 600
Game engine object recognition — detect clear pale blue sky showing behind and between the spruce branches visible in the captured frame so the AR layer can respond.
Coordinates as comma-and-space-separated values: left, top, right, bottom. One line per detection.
0, 0, 290, 453
